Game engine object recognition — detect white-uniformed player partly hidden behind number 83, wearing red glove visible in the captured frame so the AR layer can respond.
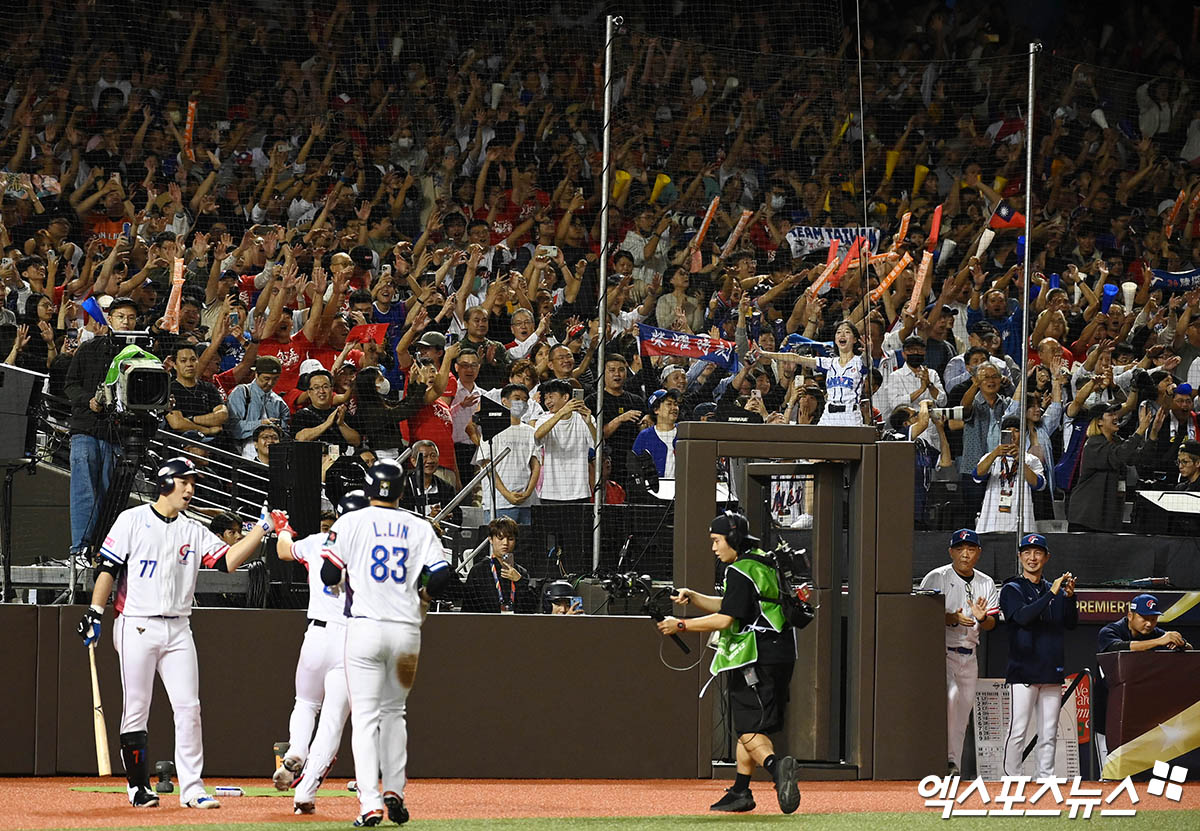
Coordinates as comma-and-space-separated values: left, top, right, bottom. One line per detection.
272, 490, 370, 814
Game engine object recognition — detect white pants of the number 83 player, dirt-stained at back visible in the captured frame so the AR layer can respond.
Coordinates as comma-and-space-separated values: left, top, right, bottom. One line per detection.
346, 617, 421, 813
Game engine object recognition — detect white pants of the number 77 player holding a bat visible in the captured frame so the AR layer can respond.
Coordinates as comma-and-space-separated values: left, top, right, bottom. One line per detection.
113, 615, 205, 805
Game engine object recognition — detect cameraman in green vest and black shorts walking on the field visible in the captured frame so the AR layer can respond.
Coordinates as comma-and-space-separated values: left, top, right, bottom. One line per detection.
658, 512, 800, 814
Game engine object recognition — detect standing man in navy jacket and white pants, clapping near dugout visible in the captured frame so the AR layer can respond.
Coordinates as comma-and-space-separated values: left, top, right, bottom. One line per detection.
1000, 534, 1079, 779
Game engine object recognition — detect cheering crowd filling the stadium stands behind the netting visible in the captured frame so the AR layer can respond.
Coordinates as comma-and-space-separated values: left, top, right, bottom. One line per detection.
0, 0, 1200, 557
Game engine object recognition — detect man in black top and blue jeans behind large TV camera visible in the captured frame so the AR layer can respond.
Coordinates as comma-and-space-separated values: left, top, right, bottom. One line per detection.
64, 298, 138, 555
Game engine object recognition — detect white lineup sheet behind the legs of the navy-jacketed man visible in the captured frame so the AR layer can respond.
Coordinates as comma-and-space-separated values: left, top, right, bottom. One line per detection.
974, 678, 1079, 782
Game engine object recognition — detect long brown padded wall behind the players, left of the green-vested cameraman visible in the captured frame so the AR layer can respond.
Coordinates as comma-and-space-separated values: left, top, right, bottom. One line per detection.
51, 606, 702, 779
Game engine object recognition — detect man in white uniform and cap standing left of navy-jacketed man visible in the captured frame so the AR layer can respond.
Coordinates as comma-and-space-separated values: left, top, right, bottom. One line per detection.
920, 528, 1000, 776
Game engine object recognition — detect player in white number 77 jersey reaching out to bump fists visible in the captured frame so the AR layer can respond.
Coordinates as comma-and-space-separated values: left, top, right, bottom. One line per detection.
78, 458, 287, 808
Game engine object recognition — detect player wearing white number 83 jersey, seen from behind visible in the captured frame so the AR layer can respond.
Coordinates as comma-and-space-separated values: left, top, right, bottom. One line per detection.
322, 459, 452, 826
